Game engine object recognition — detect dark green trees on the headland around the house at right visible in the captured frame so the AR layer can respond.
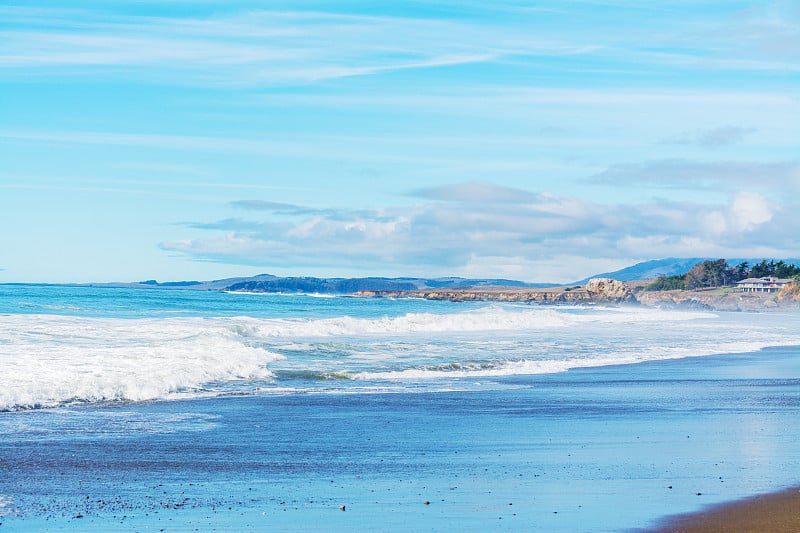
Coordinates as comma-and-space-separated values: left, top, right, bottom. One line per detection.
645, 259, 800, 291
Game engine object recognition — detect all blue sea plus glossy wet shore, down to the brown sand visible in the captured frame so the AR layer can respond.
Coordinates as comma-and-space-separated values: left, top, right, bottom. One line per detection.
0, 285, 800, 531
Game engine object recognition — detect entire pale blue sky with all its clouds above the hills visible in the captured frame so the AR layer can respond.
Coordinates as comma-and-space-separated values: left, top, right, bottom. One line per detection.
0, 0, 800, 283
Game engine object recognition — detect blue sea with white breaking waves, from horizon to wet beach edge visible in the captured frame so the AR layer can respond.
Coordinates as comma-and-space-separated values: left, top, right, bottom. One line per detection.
0, 286, 800, 411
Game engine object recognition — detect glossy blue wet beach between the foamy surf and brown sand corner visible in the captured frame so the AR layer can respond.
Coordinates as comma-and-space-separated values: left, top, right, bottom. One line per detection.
0, 347, 800, 533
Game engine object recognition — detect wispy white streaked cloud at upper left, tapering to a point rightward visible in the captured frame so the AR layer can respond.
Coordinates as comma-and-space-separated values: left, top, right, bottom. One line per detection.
0, 8, 512, 85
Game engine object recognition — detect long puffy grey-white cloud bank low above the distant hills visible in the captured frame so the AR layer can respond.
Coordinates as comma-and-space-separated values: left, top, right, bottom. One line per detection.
162, 183, 798, 282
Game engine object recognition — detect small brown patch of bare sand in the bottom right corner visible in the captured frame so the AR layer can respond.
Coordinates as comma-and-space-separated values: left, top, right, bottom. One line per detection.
653, 487, 800, 533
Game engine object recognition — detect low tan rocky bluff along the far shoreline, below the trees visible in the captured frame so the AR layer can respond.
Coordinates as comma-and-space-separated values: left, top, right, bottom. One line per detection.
354, 278, 800, 311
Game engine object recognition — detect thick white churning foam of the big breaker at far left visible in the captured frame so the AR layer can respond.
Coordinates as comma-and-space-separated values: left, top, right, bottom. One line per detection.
0, 315, 281, 410
